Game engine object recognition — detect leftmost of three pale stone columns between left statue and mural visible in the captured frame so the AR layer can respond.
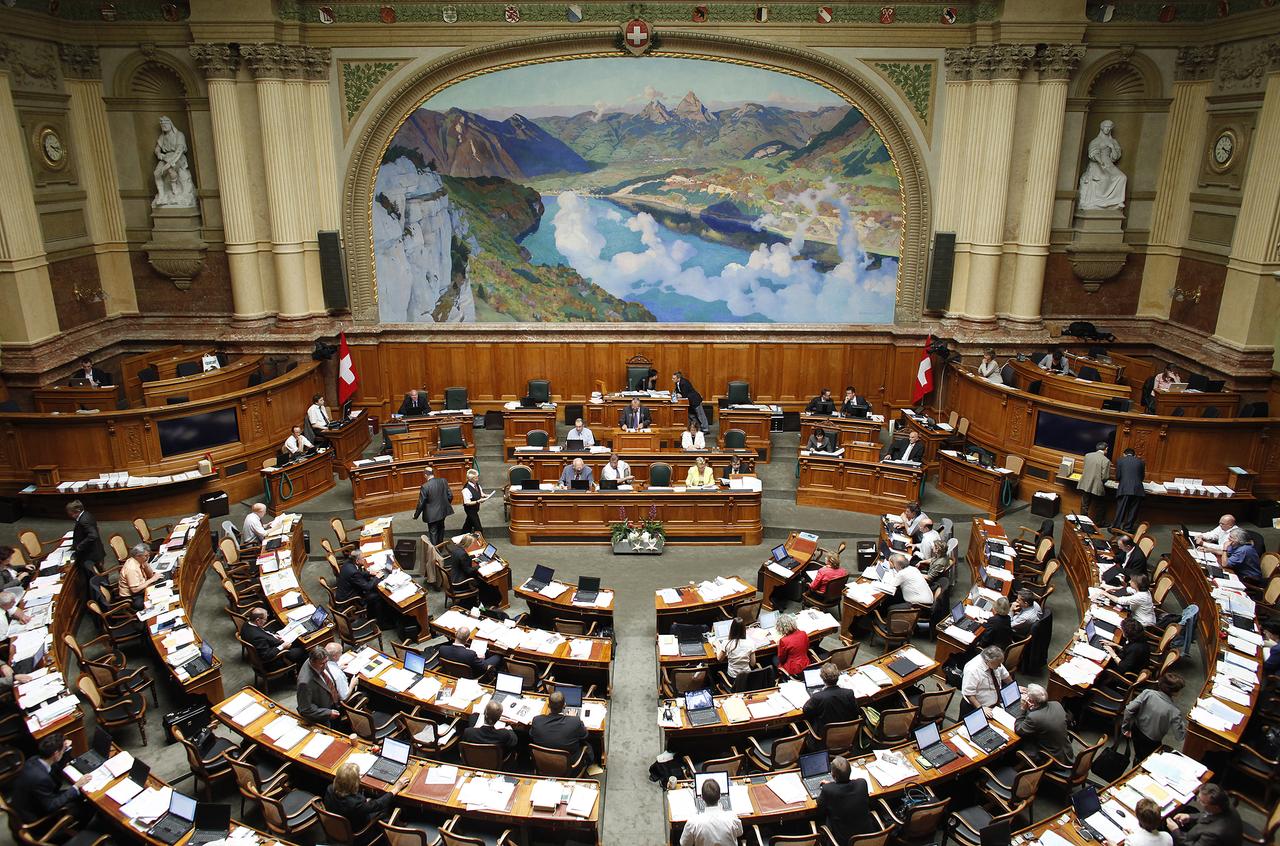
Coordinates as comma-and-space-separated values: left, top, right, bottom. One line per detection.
189, 44, 270, 320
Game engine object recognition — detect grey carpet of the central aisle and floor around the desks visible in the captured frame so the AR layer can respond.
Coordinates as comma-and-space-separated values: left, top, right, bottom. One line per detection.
0, 430, 1277, 843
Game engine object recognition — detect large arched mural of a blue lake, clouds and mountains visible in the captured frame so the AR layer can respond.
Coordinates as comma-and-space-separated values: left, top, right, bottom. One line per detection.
371, 56, 904, 324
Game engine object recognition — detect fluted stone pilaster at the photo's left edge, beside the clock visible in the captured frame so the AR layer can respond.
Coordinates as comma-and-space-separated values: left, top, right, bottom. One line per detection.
0, 61, 59, 344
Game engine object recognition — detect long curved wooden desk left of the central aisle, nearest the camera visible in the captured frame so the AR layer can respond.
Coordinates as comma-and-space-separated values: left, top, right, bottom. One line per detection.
214, 687, 604, 843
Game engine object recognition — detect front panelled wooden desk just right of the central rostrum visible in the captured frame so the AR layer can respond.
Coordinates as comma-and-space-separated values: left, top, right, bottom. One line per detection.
796, 456, 924, 515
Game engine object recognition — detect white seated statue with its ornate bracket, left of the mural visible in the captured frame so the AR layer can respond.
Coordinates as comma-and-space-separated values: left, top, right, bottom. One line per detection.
142, 118, 209, 291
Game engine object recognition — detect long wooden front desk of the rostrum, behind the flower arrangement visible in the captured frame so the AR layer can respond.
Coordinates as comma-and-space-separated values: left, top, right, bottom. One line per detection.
509, 489, 764, 547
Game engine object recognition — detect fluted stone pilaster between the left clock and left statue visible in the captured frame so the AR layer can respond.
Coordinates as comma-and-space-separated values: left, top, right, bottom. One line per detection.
59, 44, 138, 317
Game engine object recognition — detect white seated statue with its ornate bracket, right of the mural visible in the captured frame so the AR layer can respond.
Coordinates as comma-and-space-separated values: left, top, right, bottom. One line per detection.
1066, 120, 1132, 293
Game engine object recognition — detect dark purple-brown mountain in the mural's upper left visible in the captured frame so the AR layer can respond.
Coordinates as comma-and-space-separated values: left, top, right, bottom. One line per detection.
394, 109, 591, 180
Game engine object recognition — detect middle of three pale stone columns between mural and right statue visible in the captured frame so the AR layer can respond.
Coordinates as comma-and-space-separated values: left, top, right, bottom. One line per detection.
964, 44, 1036, 321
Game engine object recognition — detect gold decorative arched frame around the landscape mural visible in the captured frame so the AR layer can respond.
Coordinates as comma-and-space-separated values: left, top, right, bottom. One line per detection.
342, 29, 933, 326
